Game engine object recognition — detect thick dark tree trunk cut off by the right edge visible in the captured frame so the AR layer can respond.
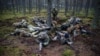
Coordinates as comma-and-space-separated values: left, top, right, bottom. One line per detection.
92, 0, 100, 29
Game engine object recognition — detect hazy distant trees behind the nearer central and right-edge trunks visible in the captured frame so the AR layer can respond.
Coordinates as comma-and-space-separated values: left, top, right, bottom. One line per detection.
0, 0, 93, 17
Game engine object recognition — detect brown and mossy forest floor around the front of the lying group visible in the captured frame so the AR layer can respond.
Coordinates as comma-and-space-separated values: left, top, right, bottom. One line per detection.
0, 19, 100, 56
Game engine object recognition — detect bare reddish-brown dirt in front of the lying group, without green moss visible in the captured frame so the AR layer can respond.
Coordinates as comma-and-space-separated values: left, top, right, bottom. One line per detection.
1, 33, 95, 56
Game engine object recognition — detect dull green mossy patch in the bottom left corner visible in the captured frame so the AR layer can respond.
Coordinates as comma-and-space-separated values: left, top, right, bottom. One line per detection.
0, 46, 20, 56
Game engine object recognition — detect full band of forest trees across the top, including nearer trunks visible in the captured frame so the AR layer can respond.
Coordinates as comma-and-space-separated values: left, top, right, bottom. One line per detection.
0, 0, 100, 27
